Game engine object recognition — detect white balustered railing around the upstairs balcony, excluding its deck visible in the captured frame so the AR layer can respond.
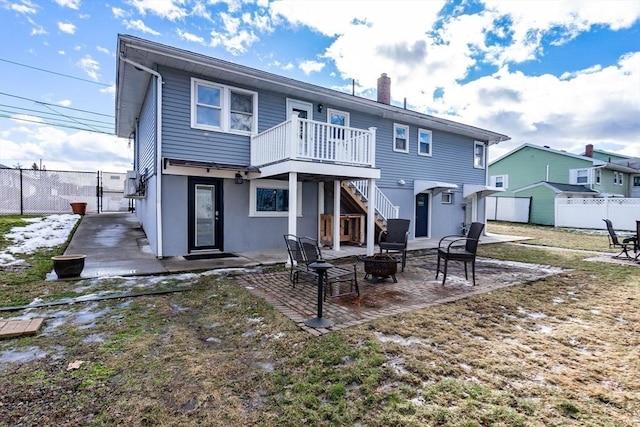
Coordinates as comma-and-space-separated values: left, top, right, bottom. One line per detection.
251, 113, 376, 167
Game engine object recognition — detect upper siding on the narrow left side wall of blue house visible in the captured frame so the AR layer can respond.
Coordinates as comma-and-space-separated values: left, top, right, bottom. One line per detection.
136, 79, 158, 176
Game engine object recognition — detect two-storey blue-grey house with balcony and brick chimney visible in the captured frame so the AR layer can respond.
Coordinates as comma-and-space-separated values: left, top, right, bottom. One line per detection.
116, 35, 509, 257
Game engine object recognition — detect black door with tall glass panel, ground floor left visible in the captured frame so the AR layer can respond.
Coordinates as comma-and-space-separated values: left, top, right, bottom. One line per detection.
188, 178, 223, 252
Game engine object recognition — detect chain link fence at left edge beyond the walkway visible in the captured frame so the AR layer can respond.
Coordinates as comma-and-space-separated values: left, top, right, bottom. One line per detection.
0, 168, 129, 215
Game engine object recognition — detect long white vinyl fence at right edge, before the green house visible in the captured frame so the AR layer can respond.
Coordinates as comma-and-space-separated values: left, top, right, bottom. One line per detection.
555, 198, 640, 231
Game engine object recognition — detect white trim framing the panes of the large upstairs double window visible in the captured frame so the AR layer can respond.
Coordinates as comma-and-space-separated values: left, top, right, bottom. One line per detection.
190, 77, 258, 135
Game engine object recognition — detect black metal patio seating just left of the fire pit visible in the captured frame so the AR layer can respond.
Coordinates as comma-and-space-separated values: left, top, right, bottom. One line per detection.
284, 234, 360, 300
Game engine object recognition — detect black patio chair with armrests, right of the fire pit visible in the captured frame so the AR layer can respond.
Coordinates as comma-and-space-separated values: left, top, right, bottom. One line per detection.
436, 222, 484, 286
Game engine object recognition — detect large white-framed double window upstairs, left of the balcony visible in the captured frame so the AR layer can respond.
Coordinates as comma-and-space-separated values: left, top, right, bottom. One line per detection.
191, 78, 258, 135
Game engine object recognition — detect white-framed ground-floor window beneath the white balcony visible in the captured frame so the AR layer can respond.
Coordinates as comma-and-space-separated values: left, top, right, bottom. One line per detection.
249, 179, 302, 217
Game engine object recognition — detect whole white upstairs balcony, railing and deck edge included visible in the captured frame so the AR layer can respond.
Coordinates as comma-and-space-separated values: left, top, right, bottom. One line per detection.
251, 113, 380, 178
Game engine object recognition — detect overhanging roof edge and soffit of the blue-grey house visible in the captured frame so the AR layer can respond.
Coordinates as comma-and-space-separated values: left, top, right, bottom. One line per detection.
116, 34, 511, 144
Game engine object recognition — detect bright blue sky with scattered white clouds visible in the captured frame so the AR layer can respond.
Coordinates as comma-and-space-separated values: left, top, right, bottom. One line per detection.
0, 0, 640, 172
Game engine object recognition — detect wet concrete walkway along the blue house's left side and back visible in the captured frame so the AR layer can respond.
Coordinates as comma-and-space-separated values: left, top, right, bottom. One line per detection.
61, 212, 524, 279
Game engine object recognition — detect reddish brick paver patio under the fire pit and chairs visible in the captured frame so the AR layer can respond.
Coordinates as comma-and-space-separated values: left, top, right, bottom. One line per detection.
237, 255, 562, 335
